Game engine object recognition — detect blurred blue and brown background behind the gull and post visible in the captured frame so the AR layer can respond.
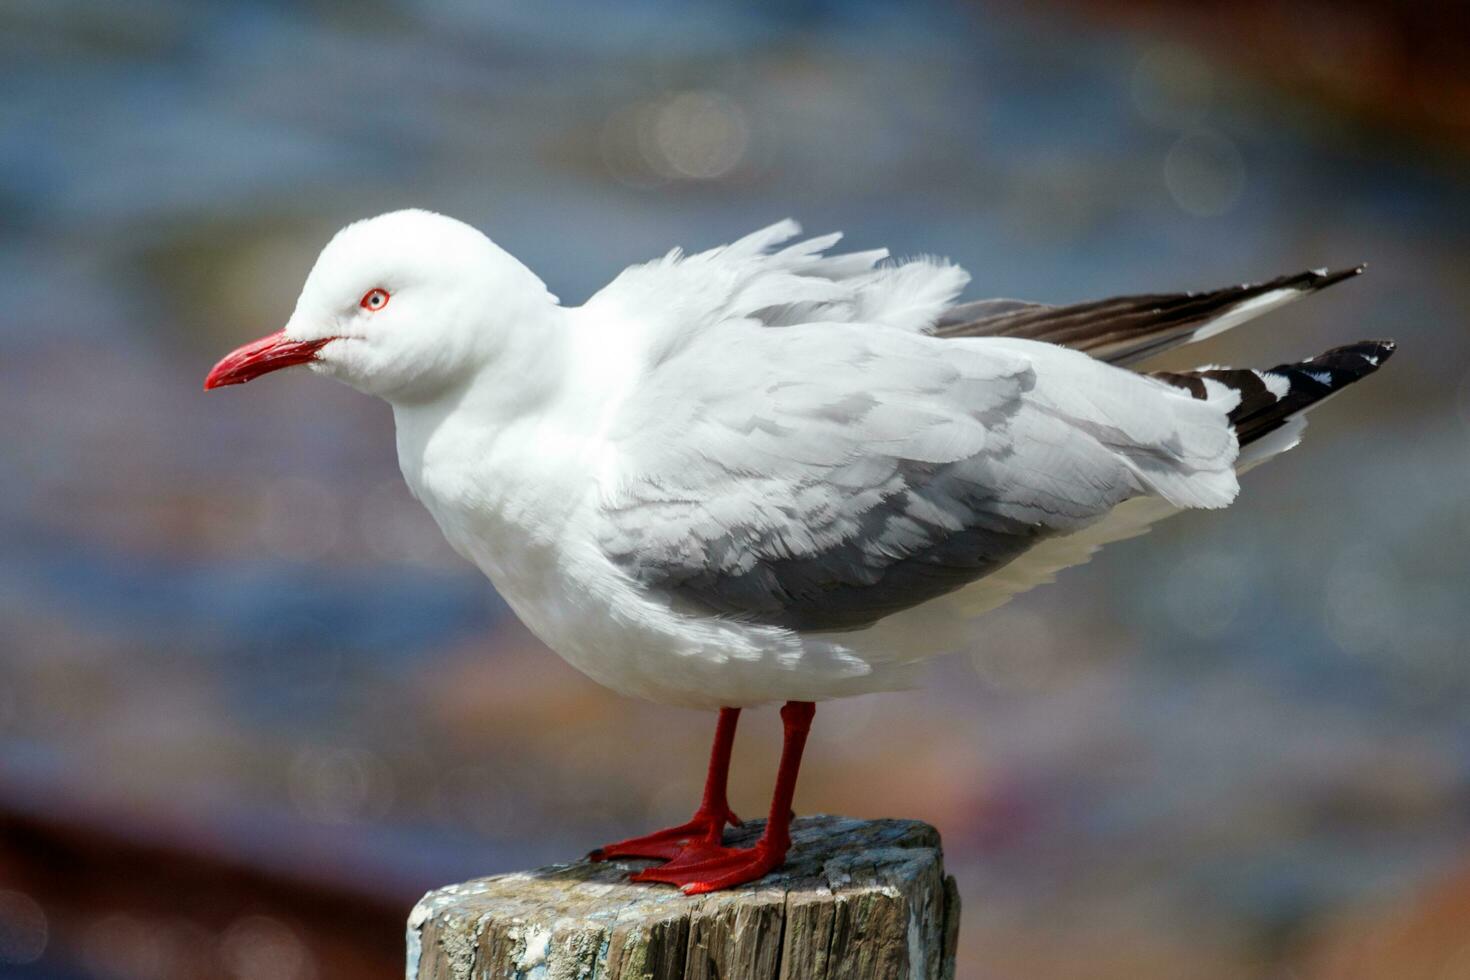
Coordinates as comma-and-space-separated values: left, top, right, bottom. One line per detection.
0, 0, 1470, 980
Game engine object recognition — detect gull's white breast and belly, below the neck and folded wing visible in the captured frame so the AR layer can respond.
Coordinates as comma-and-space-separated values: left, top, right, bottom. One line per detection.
395, 399, 908, 708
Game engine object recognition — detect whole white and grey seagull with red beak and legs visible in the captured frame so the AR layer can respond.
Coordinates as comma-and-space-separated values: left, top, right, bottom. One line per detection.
204, 210, 1394, 893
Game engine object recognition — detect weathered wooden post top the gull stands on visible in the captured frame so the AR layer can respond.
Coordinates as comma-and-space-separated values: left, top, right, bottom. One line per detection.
407, 817, 960, 980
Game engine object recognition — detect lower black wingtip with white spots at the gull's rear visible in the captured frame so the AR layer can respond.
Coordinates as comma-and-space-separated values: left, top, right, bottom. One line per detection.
1151, 341, 1394, 469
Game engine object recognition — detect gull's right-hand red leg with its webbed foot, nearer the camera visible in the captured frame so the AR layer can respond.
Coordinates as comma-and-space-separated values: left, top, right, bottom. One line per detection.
632, 701, 816, 895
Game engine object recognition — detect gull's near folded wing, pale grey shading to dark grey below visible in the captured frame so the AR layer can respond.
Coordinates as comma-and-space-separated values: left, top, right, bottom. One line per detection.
600, 325, 1233, 632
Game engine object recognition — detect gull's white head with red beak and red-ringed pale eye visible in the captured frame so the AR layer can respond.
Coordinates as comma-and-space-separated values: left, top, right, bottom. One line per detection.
204, 210, 556, 401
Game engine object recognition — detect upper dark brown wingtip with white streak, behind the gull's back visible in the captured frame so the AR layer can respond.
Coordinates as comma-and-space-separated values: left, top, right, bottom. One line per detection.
932, 266, 1364, 364
